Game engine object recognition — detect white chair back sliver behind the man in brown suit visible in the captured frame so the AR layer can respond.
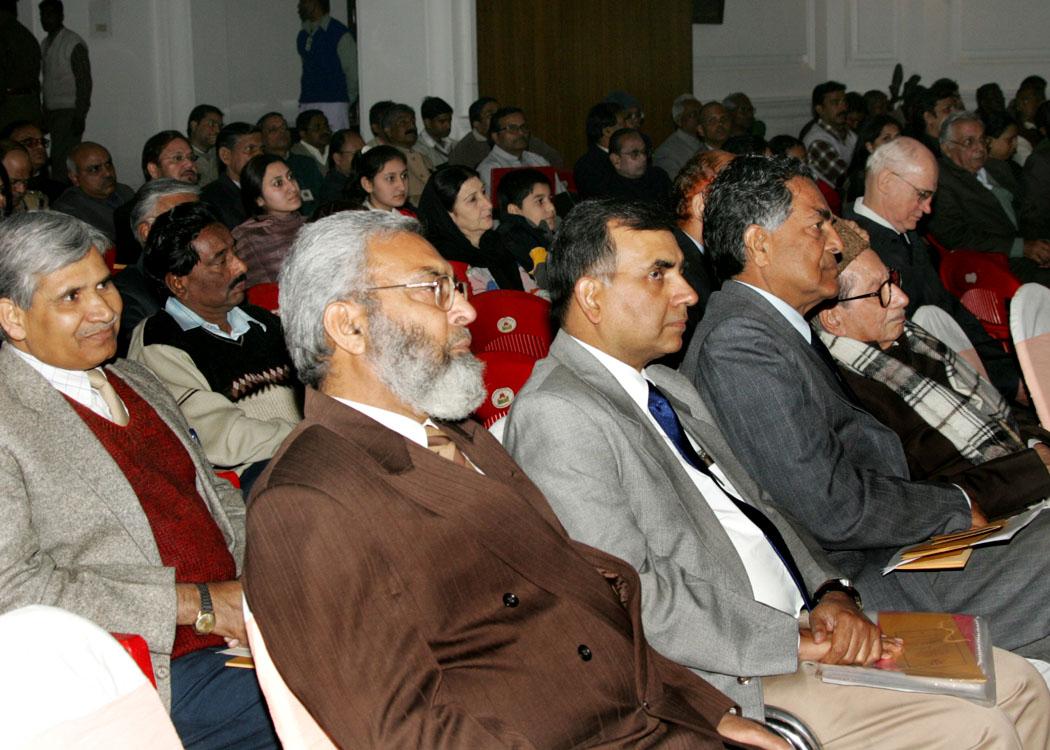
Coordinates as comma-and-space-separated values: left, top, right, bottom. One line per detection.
242, 597, 335, 750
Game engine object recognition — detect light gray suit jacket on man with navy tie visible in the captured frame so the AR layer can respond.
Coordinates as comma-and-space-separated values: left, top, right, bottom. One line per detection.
505, 332, 838, 718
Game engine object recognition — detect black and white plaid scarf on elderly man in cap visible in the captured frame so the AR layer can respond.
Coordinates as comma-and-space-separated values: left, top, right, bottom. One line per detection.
817, 321, 1025, 464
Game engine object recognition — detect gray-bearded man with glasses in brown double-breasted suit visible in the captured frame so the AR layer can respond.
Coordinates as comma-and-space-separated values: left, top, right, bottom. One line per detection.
245, 206, 782, 748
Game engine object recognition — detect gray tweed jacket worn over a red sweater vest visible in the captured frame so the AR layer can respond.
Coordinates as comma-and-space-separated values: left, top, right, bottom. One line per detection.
0, 346, 245, 703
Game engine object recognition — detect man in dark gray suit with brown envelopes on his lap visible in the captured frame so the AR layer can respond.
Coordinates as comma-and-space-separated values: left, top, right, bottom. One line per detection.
681, 157, 1050, 660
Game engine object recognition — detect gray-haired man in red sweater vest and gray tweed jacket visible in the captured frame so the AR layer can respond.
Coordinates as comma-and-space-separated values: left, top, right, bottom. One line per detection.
0, 211, 276, 748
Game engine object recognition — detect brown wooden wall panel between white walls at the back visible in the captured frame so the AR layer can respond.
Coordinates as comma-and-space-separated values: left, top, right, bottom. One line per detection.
477, 0, 693, 167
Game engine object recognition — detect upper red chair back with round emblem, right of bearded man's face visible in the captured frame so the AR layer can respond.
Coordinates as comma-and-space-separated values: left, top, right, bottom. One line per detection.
469, 289, 551, 359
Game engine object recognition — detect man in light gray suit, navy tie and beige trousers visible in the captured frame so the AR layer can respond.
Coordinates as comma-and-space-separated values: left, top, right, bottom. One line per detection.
505, 201, 1050, 748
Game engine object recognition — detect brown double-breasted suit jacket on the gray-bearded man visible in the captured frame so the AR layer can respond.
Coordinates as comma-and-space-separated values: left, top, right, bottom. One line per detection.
244, 391, 732, 748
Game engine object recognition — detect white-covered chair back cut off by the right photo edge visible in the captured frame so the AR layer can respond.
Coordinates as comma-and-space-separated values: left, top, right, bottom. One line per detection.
1010, 284, 1050, 426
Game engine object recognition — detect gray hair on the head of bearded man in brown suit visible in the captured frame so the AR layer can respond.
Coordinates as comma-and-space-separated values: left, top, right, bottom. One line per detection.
277, 211, 422, 387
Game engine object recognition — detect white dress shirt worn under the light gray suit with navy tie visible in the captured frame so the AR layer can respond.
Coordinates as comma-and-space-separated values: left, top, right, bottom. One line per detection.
574, 338, 803, 617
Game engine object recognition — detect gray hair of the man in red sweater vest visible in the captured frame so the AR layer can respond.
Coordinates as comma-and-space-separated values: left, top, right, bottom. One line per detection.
0, 211, 110, 338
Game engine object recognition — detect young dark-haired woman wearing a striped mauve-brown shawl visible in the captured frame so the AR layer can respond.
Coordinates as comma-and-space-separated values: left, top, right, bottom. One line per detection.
233, 153, 305, 287
